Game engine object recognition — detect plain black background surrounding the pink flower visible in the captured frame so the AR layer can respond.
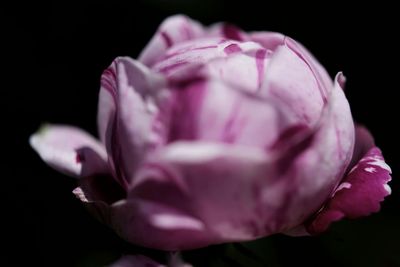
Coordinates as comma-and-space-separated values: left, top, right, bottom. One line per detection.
0, 0, 400, 266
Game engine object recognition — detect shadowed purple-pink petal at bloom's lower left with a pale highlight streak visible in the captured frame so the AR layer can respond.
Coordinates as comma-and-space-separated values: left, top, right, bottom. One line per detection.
110, 199, 219, 251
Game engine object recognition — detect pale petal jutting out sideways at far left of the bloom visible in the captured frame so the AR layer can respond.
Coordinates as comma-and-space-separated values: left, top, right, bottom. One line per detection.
29, 125, 109, 177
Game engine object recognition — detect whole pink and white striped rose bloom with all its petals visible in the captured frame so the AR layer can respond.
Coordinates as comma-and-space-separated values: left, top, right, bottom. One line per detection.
30, 16, 390, 250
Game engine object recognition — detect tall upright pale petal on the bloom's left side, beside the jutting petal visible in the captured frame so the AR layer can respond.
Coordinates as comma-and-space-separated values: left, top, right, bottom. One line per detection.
98, 57, 164, 186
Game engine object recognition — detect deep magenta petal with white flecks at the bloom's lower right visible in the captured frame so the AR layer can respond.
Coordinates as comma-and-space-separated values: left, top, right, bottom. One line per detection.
307, 147, 391, 234
